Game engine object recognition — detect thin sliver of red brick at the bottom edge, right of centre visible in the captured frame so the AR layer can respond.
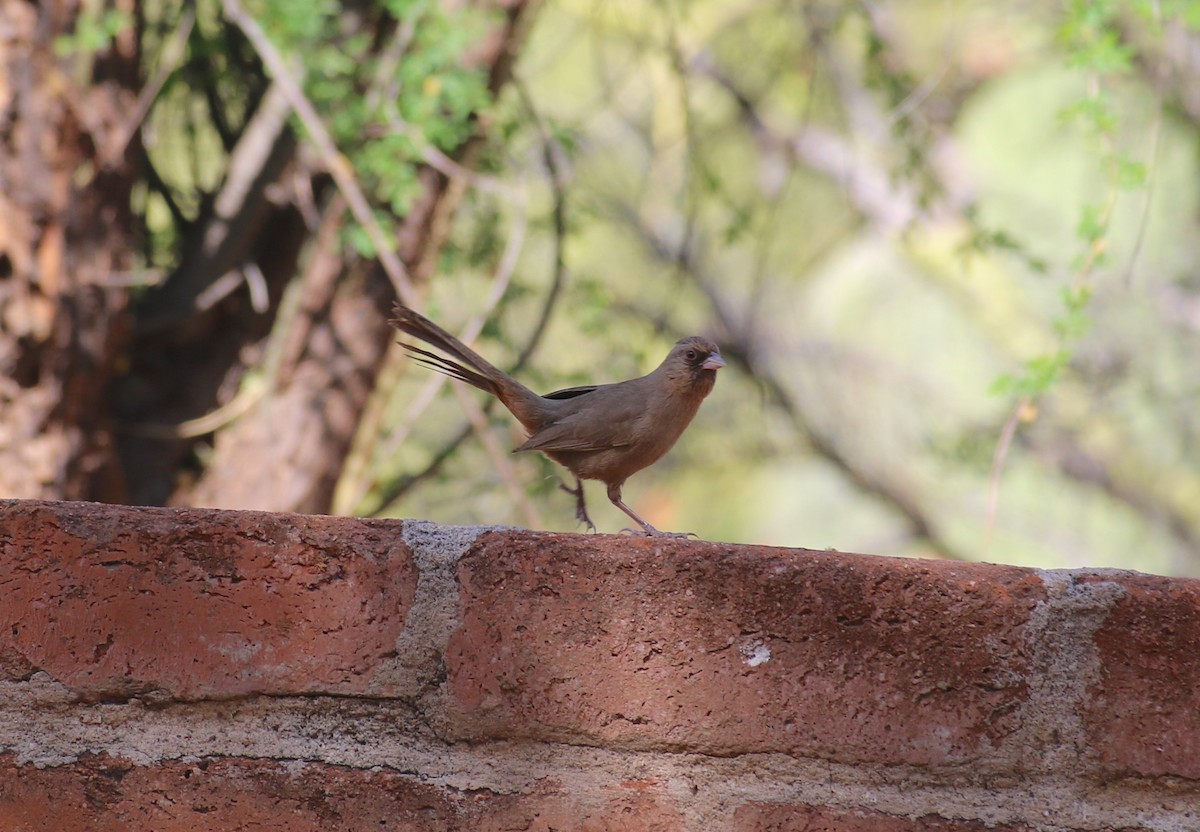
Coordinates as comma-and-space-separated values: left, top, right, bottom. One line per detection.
733, 803, 1033, 832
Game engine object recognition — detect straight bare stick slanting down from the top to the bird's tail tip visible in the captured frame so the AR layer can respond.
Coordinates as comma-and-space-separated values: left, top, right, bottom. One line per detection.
221, 0, 416, 306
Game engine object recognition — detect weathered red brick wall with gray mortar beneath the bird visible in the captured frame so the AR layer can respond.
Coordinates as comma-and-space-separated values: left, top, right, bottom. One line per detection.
0, 501, 1200, 832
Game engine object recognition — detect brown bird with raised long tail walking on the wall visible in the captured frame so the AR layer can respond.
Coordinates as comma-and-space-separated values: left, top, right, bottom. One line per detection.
391, 304, 725, 537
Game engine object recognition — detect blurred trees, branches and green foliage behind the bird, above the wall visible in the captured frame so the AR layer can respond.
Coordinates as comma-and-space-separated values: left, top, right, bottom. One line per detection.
0, 0, 1200, 575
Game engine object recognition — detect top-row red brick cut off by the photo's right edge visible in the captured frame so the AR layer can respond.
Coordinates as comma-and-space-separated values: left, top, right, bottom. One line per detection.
1084, 574, 1200, 779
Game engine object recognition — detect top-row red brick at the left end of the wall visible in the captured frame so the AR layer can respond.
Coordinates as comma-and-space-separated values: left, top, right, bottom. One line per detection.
0, 503, 416, 699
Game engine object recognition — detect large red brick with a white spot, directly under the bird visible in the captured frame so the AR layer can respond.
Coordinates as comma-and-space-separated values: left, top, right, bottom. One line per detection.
446, 533, 1044, 765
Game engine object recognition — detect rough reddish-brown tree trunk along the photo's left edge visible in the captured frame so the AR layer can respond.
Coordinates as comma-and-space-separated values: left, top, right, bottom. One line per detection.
0, 0, 138, 501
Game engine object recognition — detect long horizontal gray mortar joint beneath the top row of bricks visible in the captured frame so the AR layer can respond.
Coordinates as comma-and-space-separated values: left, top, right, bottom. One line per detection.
0, 674, 1200, 832
